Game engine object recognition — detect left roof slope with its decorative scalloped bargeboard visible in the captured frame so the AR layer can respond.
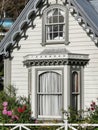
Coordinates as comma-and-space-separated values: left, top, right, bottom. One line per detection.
0, 0, 45, 57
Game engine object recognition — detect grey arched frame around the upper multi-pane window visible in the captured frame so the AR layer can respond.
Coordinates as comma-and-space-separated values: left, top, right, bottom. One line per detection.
41, 4, 69, 46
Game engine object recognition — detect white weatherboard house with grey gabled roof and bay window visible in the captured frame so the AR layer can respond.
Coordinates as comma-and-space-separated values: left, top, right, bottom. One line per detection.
0, 0, 98, 119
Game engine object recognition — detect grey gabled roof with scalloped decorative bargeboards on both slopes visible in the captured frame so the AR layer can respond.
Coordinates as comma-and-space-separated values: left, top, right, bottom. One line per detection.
0, 0, 98, 56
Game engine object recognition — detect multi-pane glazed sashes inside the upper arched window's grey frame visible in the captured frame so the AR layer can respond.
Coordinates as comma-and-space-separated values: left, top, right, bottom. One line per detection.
46, 8, 65, 40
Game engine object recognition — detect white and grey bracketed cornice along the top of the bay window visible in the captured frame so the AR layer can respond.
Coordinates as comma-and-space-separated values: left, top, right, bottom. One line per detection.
23, 49, 89, 67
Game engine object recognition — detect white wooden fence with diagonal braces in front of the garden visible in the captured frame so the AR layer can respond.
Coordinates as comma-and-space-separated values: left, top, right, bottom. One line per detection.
0, 121, 98, 130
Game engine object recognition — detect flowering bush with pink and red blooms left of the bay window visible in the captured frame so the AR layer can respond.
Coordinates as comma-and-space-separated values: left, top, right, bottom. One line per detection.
0, 86, 31, 123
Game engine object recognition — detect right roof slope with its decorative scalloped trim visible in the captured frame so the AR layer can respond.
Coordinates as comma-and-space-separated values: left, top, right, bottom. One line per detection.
68, 0, 98, 45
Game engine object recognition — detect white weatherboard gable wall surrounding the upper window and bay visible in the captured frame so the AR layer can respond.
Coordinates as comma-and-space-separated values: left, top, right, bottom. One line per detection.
11, 2, 98, 107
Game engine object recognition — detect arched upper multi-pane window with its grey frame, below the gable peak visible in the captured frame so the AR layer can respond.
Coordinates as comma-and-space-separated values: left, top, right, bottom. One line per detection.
42, 5, 68, 44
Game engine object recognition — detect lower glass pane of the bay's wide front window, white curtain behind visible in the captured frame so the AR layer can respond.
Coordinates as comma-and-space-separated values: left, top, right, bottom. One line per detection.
38, 95, 62, 116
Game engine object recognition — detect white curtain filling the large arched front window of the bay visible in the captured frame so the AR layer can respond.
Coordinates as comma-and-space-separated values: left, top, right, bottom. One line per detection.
38, 72, 62, 116
